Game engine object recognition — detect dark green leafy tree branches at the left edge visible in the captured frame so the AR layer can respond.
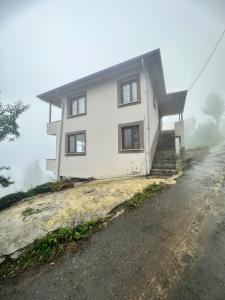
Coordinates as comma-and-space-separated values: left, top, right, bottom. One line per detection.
0, 101, 29, 187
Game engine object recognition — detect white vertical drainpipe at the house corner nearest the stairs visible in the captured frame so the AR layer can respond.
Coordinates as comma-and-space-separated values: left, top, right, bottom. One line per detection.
141, 58, 151, 175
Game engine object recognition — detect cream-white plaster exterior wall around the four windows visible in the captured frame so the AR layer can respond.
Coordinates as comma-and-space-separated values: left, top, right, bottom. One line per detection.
53, 71, 158, 178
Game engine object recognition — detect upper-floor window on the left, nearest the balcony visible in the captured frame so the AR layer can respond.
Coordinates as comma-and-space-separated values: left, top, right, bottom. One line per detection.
68, 95, 86, 117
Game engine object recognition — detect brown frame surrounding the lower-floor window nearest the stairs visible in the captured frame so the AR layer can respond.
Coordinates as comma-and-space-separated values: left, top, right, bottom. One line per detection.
118, 121, 144, 153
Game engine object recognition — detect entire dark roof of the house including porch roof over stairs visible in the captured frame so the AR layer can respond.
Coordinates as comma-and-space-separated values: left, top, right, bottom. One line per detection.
37, 49, 187, 115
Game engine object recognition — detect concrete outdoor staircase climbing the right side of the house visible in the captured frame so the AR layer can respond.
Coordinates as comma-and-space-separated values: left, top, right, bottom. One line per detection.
150, 130, 177, 176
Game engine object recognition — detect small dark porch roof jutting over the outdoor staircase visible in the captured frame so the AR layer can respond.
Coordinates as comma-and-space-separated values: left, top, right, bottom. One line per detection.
160, 90, 187, 117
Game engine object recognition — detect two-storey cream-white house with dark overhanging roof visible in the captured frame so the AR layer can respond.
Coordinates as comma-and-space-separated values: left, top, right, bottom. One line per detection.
38, 49, 187, 178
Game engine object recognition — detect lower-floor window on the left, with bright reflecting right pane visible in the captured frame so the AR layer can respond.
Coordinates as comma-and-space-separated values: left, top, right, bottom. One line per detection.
66, 131, 86, 155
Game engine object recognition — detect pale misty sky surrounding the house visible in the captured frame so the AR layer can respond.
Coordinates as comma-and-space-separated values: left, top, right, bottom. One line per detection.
0, 0, 225, 193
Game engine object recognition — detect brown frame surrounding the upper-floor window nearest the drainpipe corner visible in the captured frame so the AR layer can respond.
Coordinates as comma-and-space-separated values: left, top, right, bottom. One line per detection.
117, 74, 141, 107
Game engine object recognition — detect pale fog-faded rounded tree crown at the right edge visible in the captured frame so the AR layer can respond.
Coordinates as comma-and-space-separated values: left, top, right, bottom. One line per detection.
203, 94, 225, 126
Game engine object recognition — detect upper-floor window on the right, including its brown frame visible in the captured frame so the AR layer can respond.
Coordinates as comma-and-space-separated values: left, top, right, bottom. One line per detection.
118, 75, 141, 106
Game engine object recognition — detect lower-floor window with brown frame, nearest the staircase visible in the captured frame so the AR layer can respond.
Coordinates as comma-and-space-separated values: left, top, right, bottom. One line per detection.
118, 121, 144, 152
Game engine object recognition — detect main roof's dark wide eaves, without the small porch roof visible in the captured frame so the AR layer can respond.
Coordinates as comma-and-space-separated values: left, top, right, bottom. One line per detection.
37, 49, 166, 107
